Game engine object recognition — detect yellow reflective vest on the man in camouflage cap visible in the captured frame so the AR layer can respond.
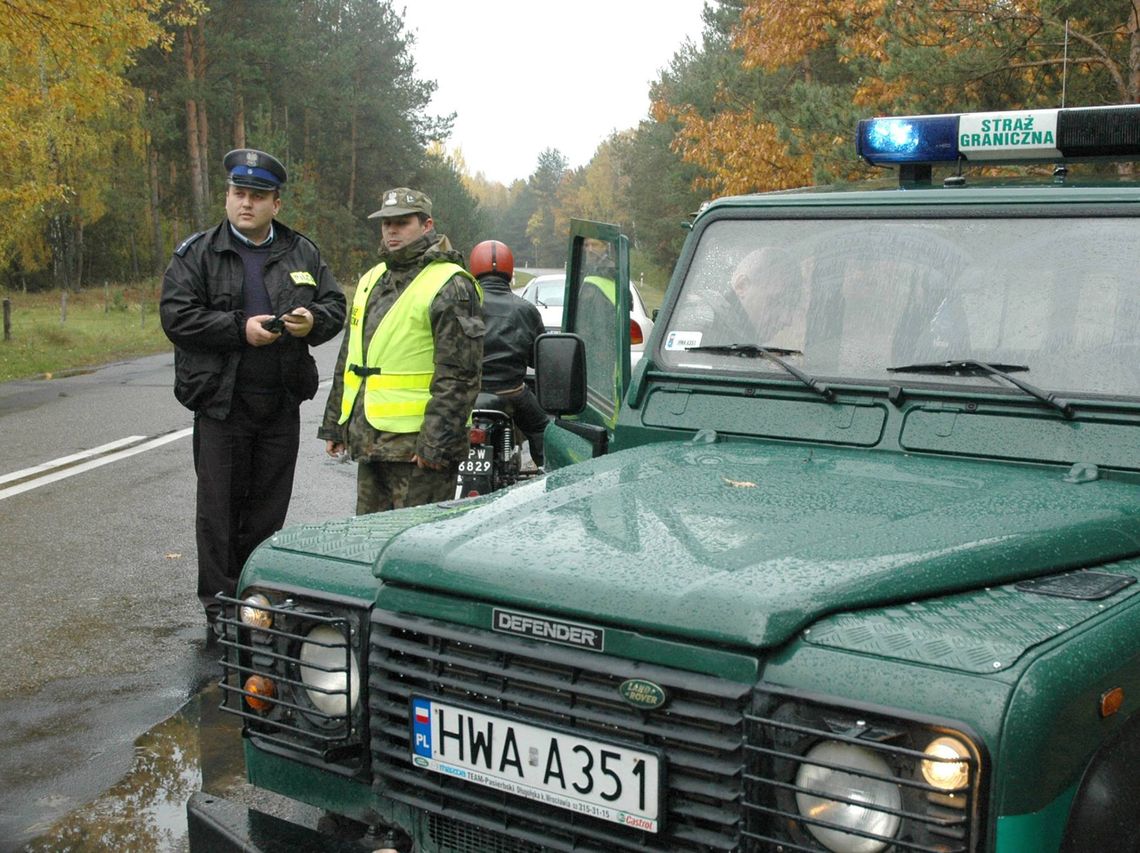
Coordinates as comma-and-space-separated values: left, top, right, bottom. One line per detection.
340, 261, 482, 432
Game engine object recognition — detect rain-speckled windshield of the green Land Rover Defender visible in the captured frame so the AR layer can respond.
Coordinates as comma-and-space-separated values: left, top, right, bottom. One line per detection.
661, 218, 1140, 396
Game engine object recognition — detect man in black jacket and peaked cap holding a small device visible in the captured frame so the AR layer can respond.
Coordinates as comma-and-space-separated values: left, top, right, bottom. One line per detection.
160, 148, 344, 623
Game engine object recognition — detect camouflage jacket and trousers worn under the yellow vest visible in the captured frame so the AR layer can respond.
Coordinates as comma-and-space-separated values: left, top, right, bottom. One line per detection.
317, 230, 485, 515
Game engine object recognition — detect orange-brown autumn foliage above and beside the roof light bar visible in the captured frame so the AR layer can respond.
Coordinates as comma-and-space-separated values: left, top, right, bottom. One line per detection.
652, 0, 1140, 198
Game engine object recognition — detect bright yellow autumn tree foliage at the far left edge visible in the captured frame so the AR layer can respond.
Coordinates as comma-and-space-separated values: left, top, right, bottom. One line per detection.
0, 0, 182, 286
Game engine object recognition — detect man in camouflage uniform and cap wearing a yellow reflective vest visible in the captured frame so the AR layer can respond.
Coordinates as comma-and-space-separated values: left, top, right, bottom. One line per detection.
317, 187, 483, 515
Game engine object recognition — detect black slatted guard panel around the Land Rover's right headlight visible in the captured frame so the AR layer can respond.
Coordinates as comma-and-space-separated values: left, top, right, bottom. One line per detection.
746, 691, 982, 853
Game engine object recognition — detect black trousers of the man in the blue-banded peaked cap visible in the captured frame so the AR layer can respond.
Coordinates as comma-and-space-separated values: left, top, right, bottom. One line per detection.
194, 393, 301, 617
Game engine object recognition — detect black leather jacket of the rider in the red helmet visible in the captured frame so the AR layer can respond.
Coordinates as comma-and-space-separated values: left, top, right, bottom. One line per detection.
479, 274, 545, 392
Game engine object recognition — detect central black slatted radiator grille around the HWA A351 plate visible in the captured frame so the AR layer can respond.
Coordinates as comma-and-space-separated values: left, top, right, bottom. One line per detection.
368, 610, 752, 853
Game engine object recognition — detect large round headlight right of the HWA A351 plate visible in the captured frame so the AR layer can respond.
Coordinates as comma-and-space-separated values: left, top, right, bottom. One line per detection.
796, 740, 903, 853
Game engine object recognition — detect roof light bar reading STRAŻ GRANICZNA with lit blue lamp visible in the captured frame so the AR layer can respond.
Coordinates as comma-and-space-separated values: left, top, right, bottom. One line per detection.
855, 104, 1140, 165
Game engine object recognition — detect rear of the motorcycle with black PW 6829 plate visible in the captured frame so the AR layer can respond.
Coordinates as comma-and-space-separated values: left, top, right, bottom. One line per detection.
456, 393, 537, 497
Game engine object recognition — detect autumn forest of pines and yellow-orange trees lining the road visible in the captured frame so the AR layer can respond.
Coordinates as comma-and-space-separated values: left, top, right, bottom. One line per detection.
0, 0, 1140, 379
